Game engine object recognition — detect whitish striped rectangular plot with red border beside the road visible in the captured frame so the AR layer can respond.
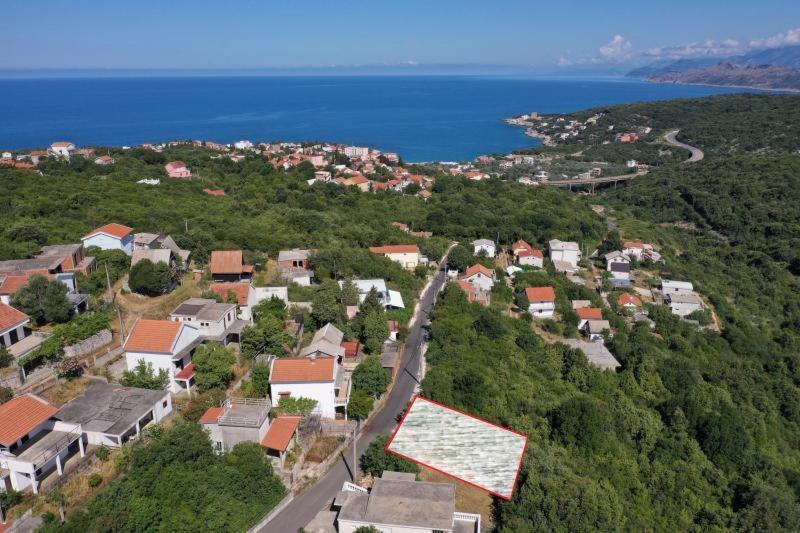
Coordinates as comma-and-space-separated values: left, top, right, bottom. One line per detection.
386, 396, 528, 499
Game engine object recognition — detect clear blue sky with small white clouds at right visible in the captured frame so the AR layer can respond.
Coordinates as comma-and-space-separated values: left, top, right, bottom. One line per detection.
0, 0, 800, 72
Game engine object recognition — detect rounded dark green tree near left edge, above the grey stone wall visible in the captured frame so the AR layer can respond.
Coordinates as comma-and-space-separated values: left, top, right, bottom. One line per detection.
11, 275, 73, 324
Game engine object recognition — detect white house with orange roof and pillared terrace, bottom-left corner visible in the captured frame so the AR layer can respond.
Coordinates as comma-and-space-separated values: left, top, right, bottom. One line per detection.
0, 394, 85, 492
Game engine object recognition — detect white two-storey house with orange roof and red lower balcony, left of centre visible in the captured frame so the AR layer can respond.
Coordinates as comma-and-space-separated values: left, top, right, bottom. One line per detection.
122, 319, 202, 393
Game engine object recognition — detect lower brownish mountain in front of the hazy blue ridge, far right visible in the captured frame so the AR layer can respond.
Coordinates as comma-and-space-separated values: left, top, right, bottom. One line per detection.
648, 61, 800, 90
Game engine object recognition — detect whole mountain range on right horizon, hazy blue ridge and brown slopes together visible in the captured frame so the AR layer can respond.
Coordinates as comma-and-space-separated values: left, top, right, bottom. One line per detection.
627, 45, 800, 90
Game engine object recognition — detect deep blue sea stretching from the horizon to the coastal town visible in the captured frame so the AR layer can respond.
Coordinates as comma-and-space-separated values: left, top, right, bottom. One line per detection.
0, 76, 752, 162
